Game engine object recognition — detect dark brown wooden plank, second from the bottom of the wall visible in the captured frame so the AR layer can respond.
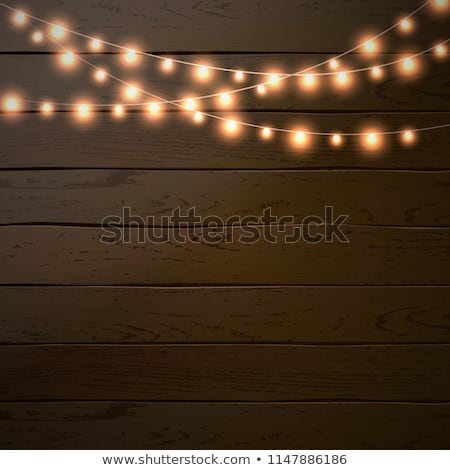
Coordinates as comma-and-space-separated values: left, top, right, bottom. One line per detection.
0, 345, 450, 402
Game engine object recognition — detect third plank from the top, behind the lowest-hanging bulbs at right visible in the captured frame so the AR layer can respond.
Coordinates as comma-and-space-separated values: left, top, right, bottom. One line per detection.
0, 112, 450, 170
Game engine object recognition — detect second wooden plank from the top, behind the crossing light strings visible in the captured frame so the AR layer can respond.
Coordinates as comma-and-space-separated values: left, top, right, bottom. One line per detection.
0, 54, 450, 112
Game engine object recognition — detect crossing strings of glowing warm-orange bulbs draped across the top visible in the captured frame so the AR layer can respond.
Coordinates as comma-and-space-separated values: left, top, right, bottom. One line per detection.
0, 0, 450, 149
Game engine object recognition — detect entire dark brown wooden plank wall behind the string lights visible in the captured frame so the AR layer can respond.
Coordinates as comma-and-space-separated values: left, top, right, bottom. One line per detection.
0, 0, 450, 449
